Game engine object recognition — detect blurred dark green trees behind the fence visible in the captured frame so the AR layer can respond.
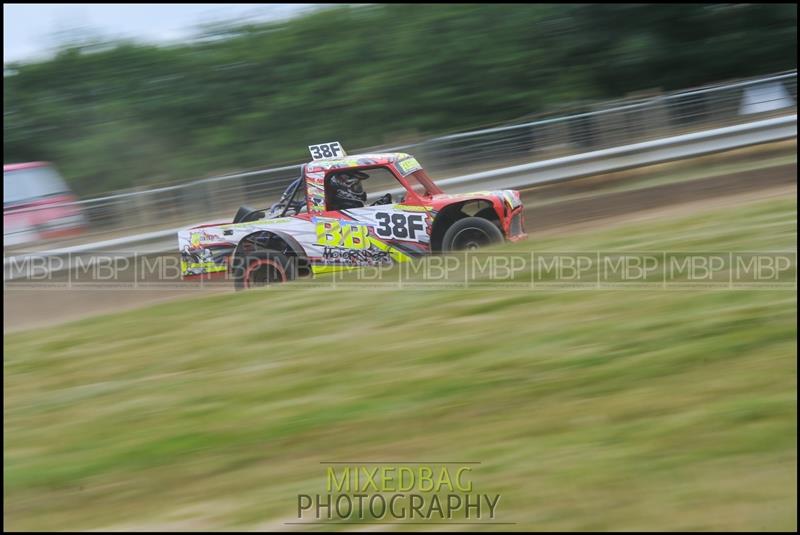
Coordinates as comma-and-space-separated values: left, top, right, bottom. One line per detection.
3, 4, 797, 195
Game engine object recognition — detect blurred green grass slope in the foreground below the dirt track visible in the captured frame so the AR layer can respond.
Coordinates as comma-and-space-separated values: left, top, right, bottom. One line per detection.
3, 196, 797, 530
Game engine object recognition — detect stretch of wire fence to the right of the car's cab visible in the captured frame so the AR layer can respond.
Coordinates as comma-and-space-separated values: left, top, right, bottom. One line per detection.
412, 71, 797, 171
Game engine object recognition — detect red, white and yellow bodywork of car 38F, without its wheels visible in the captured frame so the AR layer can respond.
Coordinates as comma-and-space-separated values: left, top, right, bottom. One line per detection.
178, 153, 526, 278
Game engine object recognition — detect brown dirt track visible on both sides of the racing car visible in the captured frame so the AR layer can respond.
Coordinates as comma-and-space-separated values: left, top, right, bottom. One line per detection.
3, 163, 797, 331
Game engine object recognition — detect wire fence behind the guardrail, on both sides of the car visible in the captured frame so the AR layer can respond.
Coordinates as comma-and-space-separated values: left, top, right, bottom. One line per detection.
3, 71, 797, 248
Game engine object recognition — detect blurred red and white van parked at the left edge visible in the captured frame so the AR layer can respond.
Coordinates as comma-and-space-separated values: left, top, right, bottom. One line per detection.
3, 162, 87, 247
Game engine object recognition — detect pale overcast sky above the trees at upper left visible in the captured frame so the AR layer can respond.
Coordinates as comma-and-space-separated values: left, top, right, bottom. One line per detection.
3, 4, 322, 63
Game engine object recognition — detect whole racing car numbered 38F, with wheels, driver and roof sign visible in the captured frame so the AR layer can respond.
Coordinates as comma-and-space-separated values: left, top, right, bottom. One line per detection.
178, 142, 527, 289
